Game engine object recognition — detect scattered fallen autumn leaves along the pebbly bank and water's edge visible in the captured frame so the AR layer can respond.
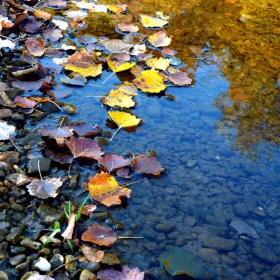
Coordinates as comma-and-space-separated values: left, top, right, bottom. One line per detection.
0, 0, 192, 279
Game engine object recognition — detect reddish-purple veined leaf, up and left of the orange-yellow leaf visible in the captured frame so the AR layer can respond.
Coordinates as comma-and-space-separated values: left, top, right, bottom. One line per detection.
65, 136, 104, 160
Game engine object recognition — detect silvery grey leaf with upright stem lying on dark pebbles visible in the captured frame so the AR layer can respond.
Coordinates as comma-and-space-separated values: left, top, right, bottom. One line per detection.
26, 178, 62, 199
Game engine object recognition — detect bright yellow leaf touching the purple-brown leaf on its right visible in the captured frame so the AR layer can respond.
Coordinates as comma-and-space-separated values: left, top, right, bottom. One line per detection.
133, 69, 166, 93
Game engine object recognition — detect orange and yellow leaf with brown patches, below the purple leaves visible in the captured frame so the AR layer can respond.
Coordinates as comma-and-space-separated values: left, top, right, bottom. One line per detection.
88, 172, 131, 206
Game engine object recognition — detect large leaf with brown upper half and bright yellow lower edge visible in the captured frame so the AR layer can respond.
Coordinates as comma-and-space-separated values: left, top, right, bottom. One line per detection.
65, 51, 102, 77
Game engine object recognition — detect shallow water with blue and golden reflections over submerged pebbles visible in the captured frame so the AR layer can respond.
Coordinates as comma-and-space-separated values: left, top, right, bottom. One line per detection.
19, 0, 280, 280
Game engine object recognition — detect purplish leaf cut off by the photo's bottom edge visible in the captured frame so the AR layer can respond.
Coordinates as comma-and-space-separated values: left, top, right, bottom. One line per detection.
97, 266, 144, 280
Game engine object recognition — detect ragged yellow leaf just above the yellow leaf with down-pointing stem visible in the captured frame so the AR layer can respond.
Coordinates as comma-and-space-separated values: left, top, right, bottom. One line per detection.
101, 89, 135, 108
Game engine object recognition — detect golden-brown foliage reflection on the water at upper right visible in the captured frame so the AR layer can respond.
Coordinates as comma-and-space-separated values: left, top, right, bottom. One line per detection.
92, 0, 280, 155
